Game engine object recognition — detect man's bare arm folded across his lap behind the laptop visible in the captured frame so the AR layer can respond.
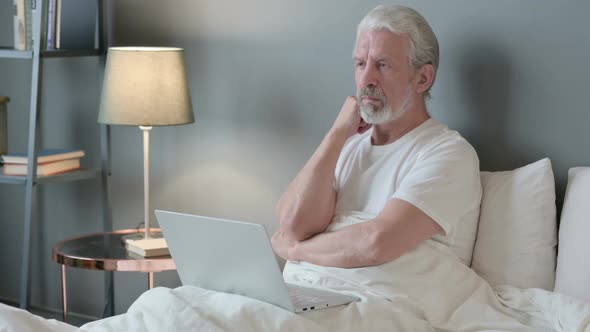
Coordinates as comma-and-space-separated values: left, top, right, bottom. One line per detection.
284, 198, 443, 268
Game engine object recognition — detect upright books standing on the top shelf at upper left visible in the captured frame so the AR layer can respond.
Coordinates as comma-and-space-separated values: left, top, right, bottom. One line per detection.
12, 0, 98, 51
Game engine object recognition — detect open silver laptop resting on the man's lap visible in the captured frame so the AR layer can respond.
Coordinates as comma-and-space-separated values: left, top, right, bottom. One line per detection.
156, 210, 358, 313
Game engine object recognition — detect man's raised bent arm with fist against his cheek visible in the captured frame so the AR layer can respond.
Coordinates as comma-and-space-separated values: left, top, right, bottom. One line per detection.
273, 97, 369, 241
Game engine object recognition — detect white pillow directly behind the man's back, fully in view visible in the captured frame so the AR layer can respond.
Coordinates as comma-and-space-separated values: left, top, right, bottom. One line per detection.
472, 158, 557, 290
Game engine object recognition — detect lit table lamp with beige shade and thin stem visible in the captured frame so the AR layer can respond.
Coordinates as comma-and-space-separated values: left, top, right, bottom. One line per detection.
98, 47, 195, 246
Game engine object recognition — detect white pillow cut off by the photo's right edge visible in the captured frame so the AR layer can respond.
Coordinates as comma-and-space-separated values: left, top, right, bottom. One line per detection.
555, 167, 590, 301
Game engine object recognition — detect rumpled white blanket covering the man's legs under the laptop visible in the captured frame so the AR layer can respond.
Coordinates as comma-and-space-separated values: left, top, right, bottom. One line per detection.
0, 241, 590, 332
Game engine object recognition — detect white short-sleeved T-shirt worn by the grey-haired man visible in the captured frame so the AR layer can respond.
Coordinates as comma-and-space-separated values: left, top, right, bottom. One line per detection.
327, 119, 482, 266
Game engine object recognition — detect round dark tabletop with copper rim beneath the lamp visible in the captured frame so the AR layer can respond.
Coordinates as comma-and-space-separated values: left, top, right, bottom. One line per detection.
52, 228, 176, 272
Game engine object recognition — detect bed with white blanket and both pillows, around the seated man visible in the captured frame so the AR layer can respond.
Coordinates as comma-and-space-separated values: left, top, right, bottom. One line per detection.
0, 159, 590, 331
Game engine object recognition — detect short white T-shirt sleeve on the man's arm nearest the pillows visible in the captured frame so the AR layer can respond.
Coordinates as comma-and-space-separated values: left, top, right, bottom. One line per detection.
390, 137, 482, 235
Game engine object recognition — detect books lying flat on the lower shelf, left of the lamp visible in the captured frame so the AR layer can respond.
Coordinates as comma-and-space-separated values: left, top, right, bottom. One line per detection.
0, 149, 84, 176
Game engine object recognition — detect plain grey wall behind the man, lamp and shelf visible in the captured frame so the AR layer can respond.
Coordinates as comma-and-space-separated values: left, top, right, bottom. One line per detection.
0, 0, 590, 315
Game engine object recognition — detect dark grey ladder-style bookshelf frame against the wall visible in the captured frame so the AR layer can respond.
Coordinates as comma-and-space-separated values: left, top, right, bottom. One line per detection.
0, 0, 114, 315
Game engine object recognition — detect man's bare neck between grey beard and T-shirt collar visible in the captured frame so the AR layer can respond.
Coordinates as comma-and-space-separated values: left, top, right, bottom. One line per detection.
371, 101, 430, 145
